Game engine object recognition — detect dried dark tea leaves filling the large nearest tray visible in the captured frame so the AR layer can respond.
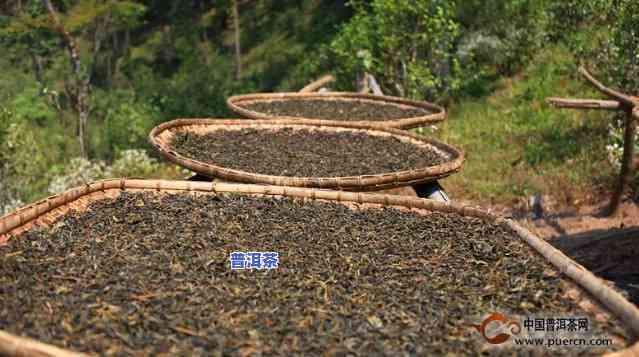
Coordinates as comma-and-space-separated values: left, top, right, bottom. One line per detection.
0, 192, 621, 356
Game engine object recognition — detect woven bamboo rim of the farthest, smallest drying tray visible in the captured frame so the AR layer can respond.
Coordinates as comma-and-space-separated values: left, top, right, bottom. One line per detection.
226, 92, 446, 129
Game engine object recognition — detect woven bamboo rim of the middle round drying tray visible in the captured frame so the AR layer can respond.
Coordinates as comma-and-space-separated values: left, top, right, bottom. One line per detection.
149, 119, 464, 191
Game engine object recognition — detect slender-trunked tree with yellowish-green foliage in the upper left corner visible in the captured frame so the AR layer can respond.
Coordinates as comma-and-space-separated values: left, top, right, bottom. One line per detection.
0, 0, 145, 157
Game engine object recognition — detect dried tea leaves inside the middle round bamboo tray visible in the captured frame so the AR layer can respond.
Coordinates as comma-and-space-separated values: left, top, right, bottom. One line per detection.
171, 128, 445, 177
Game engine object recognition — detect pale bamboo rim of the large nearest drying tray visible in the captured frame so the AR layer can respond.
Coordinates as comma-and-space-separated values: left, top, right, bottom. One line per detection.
0, 179, 639, 357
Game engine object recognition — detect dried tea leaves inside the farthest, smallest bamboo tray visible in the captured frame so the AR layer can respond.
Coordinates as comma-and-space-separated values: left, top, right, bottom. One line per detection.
241, 98, 432, 121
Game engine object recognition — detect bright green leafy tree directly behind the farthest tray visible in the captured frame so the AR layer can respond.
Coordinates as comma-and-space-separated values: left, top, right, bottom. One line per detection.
327, 0, 461, 99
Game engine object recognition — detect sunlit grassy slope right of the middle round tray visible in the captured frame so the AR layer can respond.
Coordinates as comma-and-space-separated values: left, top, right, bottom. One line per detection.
422, 47, 615, 205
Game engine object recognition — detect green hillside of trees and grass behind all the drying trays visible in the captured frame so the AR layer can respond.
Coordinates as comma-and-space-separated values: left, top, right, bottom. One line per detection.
0, 0, 639, 214
